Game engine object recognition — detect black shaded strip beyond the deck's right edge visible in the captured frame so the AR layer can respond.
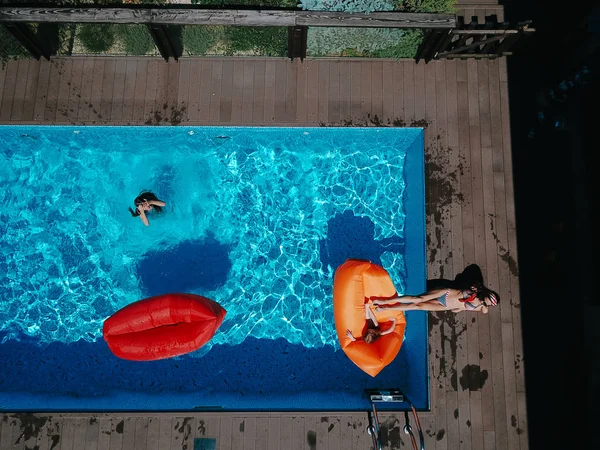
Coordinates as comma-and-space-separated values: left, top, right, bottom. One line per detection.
504, 0, 600, 449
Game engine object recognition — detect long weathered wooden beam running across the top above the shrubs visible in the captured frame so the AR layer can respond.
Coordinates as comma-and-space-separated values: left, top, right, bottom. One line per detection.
0, 6, 456, 28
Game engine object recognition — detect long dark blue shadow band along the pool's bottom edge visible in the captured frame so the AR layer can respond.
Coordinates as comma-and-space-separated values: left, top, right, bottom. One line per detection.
0, 333, 426, 410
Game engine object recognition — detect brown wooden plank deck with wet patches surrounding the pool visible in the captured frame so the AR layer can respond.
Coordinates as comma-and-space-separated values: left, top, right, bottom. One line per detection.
0, 2, 528, 450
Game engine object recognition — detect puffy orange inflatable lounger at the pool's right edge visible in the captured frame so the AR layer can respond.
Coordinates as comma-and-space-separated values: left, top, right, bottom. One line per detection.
333, 259, 406, 377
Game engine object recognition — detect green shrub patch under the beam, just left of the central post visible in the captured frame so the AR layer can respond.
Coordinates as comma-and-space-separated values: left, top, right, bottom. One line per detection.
224, 26, 287, 56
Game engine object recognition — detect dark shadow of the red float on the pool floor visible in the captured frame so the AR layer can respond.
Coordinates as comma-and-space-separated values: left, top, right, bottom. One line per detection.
137, 235, 231, 297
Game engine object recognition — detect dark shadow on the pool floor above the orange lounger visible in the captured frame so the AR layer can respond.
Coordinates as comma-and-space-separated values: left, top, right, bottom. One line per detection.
319, 211, 404, 268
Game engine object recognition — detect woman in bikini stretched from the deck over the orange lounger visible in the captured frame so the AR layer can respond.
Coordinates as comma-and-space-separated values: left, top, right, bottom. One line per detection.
373, 285, 500, 314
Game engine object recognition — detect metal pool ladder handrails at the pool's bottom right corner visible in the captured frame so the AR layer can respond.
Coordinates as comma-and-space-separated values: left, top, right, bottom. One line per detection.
366, 389, 425, 450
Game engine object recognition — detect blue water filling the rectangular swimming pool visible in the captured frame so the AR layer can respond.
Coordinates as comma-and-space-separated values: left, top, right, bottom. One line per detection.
0, 126, 429, 410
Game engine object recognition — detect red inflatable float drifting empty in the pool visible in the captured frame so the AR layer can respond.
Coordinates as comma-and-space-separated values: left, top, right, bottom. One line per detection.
102, 294, 227, 361
